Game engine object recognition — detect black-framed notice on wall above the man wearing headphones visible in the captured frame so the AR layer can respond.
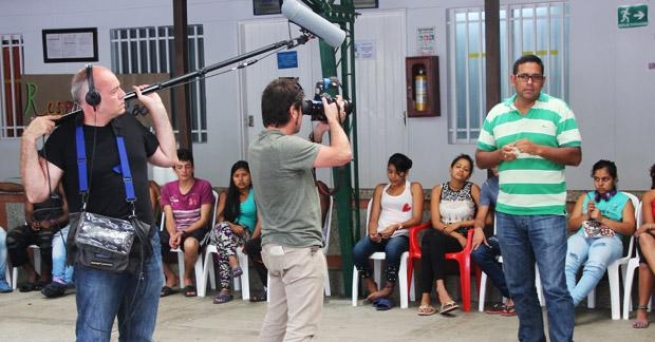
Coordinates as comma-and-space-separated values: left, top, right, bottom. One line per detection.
42, 27, 98, 63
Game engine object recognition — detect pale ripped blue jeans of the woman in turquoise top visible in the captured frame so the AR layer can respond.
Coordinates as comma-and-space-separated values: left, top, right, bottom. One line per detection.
565, 229, 623, 305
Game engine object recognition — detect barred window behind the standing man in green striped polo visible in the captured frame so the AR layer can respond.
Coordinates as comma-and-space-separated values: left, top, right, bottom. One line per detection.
448, 2, 569, 144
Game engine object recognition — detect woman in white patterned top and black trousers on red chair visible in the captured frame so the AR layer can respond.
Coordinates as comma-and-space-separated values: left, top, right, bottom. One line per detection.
418, 154, 480, 316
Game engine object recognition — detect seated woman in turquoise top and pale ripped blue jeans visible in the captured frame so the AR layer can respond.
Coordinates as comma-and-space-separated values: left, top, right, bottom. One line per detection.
565, 160, 635, 306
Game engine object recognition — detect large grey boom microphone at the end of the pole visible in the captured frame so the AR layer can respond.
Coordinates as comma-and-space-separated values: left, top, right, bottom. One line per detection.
282, 0, 346, 48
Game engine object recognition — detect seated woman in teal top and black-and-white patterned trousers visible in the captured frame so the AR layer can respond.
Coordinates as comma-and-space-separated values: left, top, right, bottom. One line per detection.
209, 160, 267, 304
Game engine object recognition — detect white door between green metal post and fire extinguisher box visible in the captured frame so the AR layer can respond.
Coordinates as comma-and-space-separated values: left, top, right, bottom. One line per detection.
355, 11, 411, 189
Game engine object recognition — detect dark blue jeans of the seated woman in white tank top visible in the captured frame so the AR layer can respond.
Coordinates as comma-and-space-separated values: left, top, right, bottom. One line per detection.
353, 235, 409, 284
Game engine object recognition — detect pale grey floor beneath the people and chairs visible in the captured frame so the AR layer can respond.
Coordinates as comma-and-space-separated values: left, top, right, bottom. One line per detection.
0, 292, 655, 342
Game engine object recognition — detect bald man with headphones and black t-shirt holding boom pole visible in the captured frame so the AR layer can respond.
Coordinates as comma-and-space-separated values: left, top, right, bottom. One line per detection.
21, 65, 177, 341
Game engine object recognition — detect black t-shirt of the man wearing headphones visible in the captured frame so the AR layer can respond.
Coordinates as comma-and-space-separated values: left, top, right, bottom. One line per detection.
42, 114, 159, 224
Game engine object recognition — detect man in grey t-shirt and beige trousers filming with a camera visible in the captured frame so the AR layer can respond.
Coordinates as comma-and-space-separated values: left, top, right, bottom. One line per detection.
248, 79, 352, 341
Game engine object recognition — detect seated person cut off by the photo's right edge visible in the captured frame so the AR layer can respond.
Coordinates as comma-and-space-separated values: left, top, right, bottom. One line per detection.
632, 164, 655, 329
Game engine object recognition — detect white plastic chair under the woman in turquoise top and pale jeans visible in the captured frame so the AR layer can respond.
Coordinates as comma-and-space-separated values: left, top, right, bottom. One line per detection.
587, 191, 640, 320
